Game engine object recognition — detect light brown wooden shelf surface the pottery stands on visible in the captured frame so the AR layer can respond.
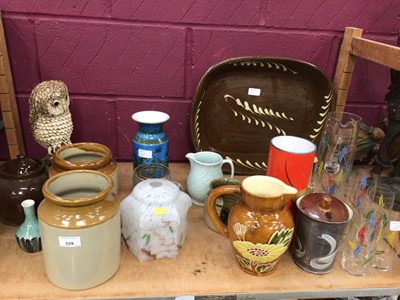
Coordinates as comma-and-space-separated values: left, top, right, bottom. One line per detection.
0, 163, 400, 299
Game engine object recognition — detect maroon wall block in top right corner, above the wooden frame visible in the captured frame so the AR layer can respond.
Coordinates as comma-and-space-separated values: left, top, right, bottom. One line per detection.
266, 0, 400, 33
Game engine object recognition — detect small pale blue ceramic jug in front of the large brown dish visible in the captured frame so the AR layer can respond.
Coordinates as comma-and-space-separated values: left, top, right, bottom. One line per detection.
186, 151, 235, 206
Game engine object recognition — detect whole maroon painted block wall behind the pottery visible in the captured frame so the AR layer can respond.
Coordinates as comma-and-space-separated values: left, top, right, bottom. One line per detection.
0, 0, 400, 161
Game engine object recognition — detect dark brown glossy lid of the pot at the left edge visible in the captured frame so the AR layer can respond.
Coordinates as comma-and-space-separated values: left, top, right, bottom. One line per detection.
0, 154, 45, 178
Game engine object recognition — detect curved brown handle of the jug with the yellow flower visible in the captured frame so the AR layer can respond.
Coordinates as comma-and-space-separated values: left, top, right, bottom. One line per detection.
207, 185, 240, 237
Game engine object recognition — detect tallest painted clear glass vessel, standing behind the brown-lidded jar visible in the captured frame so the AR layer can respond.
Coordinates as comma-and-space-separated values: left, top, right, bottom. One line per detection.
310, 112, 361, 195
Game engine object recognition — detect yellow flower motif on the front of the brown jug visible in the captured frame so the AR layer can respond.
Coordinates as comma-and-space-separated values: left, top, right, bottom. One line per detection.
233, 241, 287, 263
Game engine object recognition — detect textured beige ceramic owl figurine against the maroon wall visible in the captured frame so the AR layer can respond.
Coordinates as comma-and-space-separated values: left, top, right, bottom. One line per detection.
29, 80, 73, 156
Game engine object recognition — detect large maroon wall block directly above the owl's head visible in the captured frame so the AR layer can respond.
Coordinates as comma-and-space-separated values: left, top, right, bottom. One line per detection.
36, 20, 185, 97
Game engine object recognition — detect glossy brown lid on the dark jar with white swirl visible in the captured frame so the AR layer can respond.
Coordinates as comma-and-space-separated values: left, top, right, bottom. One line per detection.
297, 193, 349, 223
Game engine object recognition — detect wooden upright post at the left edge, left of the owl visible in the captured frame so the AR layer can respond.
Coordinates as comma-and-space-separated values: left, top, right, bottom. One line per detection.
0, 13, 25, 159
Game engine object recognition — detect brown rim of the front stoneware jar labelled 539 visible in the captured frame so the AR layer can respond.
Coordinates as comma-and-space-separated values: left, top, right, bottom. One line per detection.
42, 170, 114, 206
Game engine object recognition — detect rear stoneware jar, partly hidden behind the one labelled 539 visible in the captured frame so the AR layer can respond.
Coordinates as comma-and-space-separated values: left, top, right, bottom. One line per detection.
49, 143, 118, 194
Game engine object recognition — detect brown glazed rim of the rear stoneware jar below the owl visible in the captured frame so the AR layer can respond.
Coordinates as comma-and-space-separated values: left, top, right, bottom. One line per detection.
53, 142, 112, 170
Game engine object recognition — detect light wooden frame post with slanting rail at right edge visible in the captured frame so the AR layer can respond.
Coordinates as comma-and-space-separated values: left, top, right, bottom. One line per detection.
333, 27, 400, 112
